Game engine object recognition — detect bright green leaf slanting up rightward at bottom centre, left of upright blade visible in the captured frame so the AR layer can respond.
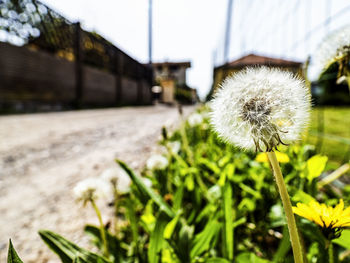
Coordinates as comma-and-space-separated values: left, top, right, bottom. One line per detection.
191, 219, 221, 259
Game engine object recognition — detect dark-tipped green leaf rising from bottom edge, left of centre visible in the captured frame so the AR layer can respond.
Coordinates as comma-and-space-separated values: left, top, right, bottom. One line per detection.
148, 211, 169, 263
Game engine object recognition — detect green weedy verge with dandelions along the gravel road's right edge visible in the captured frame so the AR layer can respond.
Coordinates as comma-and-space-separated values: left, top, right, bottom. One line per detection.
9, 109, 350, 263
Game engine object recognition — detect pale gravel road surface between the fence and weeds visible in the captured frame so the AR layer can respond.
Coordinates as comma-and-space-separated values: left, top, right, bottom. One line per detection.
0, 106, 194, 263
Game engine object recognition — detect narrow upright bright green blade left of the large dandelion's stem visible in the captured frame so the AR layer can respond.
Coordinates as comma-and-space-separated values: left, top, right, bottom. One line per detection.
222, 183, 235, 261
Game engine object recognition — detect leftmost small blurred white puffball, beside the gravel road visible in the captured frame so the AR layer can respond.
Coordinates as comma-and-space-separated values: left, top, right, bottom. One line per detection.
73, 178, 110, 203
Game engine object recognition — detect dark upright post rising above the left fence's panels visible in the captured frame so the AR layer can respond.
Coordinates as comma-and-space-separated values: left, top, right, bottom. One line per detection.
74, 22, 84, 109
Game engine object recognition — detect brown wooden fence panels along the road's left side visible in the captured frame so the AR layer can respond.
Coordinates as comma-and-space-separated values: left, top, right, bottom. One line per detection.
0, 43, 152, 111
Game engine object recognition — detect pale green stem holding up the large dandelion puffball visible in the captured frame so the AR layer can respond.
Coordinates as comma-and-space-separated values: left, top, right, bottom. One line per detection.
267, 151, 303, 263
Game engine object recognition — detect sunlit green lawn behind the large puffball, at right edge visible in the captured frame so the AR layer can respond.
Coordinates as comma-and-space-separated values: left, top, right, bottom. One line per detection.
306, 107, 350, 167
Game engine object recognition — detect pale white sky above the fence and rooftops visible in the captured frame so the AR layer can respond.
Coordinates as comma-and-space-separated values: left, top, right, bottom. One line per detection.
42, 0, 350, 98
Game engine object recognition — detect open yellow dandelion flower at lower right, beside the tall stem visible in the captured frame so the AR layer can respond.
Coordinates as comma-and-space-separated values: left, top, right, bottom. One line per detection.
293, 199, 350, 239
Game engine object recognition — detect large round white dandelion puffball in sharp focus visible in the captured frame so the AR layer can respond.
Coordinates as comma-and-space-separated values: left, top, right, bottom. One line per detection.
211, 67, 310, 151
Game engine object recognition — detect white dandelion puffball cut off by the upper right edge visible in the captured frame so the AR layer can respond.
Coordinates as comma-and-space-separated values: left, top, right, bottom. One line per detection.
312, 25, 350, 78
